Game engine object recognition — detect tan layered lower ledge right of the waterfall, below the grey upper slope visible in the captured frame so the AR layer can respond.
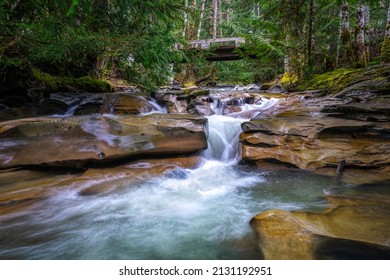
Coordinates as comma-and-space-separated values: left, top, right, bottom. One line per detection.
240, 113, 390, 170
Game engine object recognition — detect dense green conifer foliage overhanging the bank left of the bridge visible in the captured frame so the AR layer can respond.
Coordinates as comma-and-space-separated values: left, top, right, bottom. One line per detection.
0, 0, 182, 89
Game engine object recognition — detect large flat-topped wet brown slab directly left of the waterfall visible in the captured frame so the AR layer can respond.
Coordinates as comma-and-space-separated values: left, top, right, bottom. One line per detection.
0, 114, 207, 168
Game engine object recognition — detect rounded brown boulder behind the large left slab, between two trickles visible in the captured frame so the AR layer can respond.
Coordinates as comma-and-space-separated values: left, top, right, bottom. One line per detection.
100, 93, 156, 115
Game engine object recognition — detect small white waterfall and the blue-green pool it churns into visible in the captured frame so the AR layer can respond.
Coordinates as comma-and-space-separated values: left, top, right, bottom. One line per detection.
0, 94, 352, 260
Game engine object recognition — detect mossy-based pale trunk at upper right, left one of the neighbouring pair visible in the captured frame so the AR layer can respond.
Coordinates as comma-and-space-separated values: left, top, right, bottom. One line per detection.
341, 2, 354, 66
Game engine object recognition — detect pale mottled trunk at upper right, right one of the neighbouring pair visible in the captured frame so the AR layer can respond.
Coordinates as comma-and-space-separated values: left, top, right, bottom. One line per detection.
355, 6, 367, 67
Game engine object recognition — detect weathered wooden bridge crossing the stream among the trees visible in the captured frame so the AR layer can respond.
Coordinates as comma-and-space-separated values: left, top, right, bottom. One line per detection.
188, 37, 245, 61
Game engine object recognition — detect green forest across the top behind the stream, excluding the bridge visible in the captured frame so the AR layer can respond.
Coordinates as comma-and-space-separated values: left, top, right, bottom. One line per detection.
0, 0, 390, 91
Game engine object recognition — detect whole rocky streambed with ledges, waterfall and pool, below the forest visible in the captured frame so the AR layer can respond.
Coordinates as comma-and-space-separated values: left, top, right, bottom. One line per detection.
0, 64, 390, 259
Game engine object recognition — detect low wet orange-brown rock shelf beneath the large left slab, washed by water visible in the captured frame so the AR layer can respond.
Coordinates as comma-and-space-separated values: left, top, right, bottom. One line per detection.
0, 156, 200, 214
